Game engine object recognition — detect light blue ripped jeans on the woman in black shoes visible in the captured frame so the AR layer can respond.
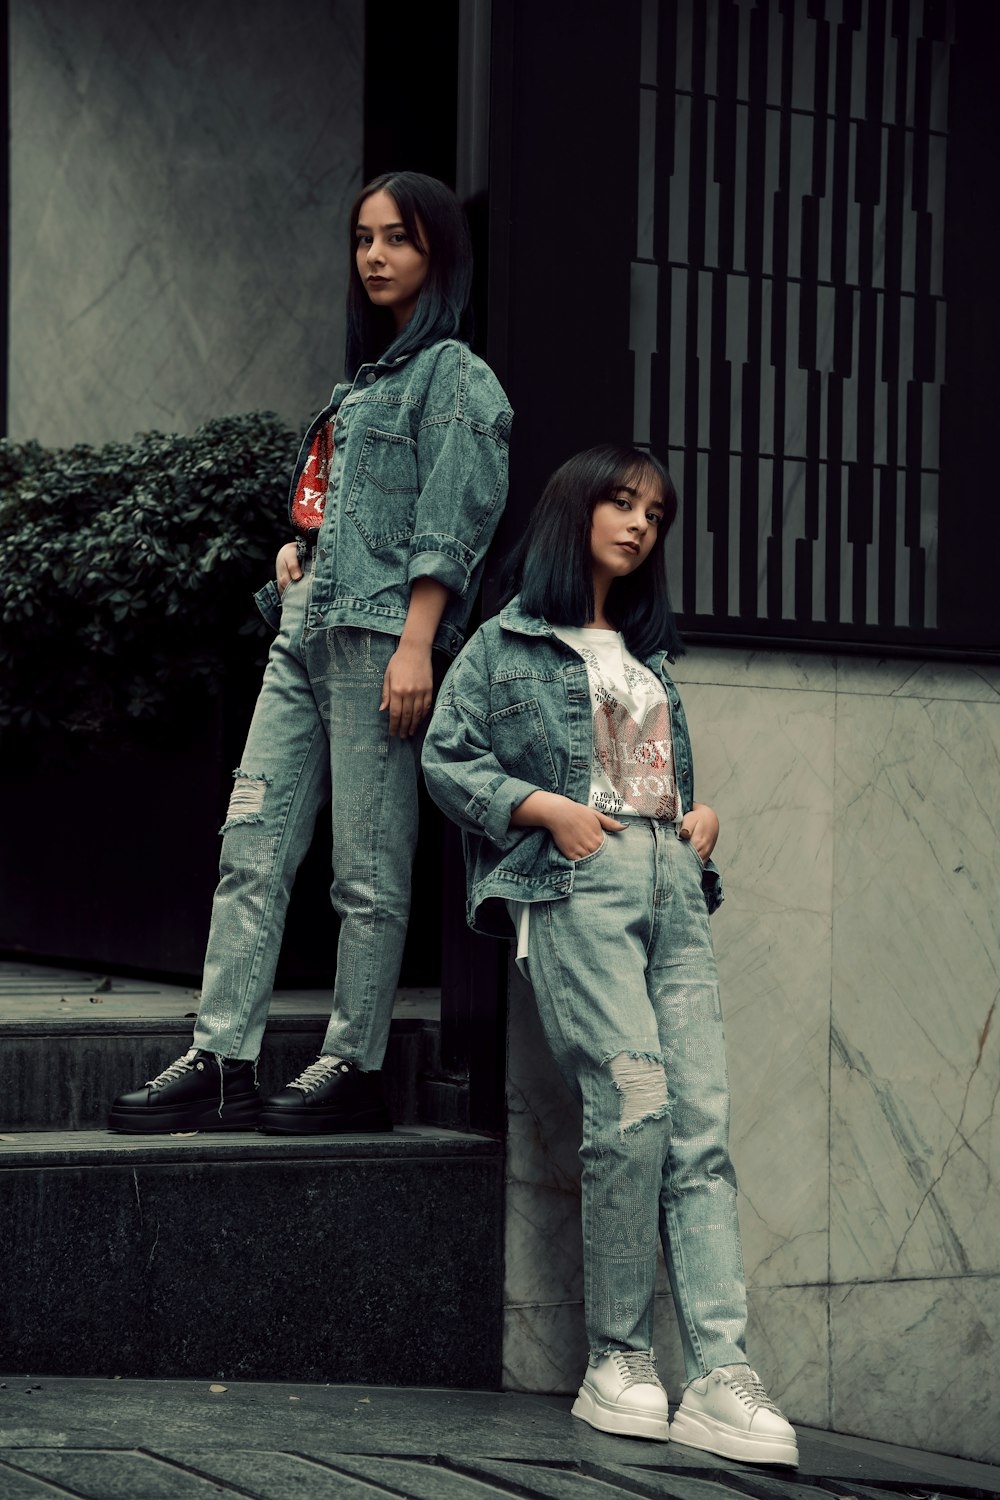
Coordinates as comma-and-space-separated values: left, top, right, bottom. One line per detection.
195, 558, 420, 1073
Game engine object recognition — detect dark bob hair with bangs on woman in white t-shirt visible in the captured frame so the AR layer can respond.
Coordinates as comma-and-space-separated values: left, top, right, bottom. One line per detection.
505, 444, 684, 660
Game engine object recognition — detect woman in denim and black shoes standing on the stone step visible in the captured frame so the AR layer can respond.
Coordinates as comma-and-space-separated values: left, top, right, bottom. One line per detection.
109, 173, 511, 1134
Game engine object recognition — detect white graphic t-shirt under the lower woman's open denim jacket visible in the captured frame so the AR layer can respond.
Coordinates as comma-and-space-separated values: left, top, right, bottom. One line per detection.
507, 626, 679, 968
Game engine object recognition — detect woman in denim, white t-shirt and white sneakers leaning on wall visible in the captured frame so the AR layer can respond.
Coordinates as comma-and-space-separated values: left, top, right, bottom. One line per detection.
423, 446, 798, 1464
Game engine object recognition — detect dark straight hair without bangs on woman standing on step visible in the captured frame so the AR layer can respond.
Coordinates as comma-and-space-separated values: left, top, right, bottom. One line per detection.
346, 173, 472, 380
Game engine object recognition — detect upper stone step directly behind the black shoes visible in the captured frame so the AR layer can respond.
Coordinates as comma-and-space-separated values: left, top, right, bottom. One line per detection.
0, 963, 449, 1133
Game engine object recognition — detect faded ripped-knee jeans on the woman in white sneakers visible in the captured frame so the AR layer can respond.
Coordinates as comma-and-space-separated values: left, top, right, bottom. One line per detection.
528, 818, 747, 1380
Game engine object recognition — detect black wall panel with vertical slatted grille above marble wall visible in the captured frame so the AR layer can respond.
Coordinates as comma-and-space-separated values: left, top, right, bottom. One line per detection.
490, 0, 1000, 656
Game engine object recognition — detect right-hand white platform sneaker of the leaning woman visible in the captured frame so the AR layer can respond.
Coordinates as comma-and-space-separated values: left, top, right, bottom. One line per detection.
670, 1365, 799, 1464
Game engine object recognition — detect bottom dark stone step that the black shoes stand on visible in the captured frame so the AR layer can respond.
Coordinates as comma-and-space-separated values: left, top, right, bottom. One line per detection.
0, 1127, 502, 1388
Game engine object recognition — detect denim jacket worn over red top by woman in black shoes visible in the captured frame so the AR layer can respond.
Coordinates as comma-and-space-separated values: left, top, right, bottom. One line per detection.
256, 339, 513, 656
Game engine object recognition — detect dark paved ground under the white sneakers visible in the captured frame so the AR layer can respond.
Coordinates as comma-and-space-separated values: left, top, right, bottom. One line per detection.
0, 1380, 1000, 1500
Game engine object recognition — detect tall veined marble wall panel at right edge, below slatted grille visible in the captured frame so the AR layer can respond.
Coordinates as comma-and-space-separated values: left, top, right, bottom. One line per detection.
831, 696, 1000, 1281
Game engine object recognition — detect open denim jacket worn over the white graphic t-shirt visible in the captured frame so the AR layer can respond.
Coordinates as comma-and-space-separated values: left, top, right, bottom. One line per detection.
423, 599, 723, 938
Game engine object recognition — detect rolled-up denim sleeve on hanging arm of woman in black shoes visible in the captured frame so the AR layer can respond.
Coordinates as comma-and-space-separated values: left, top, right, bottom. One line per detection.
408, 345, 511, 597
